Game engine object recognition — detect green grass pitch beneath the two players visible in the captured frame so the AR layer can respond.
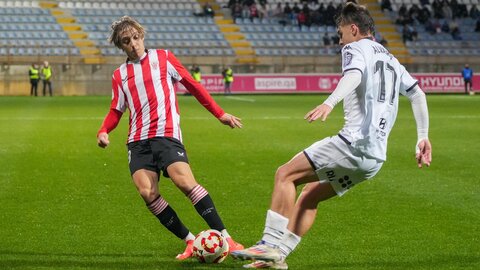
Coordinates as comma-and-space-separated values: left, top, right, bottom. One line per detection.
0, 95, 480, 269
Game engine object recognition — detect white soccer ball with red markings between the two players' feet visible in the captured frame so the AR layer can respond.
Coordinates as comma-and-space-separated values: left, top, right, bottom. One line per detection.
193, 230, 228, 263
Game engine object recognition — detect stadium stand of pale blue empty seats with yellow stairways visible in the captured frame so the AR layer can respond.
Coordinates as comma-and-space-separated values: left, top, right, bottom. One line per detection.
0, 0, 480, 69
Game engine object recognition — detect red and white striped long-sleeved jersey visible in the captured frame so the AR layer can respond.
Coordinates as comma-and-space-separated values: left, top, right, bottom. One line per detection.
110, 50, 224, 143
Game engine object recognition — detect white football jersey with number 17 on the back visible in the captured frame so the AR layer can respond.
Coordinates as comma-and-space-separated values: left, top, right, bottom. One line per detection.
340, 38, 417, 161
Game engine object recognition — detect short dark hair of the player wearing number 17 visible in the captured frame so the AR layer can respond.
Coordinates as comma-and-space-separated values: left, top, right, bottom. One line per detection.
335, 2, 375, 35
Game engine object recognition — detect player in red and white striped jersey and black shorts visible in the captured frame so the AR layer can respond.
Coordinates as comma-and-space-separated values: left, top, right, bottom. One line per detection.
97, 16, 243, 260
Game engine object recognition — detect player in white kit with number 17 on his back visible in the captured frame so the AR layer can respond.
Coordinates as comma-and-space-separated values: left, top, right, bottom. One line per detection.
232, 3, 432, 269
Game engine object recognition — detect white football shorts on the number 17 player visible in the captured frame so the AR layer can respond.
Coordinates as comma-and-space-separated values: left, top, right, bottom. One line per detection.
303, 136, 383, 196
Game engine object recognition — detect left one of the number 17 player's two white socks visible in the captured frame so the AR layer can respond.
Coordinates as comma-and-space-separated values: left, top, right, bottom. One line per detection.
262, 210, 288, 247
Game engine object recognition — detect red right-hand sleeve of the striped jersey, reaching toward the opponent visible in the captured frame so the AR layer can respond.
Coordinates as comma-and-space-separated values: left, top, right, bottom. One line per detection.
167, 52, 225, 118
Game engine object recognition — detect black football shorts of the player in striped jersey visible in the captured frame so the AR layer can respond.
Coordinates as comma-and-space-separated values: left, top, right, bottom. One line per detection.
127, 137, 188, 177
